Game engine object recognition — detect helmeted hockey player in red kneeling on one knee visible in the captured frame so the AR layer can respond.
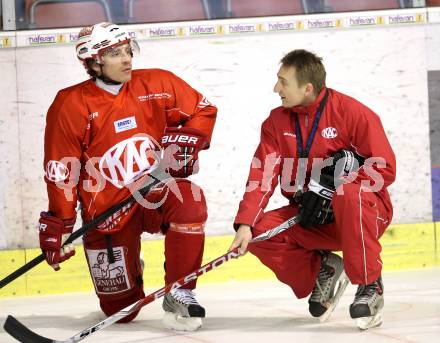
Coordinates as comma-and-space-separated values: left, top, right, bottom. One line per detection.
39, 23, 217, 330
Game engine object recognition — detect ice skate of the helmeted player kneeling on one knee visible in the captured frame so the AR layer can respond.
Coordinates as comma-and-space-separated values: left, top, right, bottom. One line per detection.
162, 289, 205, 331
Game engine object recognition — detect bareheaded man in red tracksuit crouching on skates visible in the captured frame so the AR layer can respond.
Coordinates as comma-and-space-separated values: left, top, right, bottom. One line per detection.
230, 50, 396, 329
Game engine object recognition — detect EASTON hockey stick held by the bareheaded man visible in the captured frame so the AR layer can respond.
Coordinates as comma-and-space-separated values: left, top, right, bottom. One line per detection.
3, 216, 299, 343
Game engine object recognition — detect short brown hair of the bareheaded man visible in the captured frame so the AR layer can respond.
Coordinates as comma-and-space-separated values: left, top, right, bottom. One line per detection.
281, 49, 326, 95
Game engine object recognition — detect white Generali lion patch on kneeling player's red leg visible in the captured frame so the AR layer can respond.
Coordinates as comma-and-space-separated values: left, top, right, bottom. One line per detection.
86, 247, 132, 294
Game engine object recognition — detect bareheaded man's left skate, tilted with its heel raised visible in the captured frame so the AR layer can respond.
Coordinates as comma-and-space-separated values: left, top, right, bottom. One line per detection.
309, 253, 348, 322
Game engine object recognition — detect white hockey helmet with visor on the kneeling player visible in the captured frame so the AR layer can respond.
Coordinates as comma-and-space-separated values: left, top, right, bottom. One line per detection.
76, 22, 139, 65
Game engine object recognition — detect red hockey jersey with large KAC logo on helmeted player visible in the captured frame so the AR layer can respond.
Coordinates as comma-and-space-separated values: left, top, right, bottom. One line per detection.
44, 69, 217, 227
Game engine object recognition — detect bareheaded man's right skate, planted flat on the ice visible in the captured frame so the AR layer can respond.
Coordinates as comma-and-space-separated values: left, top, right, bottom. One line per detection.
350, 277, 384, 330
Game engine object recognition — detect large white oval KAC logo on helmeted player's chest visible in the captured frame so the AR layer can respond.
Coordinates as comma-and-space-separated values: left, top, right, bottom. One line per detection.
99, 136, 159, 188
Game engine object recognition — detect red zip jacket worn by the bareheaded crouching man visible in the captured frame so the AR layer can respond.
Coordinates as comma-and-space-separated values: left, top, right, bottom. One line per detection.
235, 88, 396, 230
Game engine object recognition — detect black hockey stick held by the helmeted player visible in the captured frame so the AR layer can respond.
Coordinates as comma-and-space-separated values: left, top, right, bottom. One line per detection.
0, 168, 169, 289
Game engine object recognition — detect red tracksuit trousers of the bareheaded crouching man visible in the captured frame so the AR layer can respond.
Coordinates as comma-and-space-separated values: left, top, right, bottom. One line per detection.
249, 184, 392, 298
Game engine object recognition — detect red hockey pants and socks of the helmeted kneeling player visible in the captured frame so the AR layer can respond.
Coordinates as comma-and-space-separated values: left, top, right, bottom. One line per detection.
84, 179, 207, 322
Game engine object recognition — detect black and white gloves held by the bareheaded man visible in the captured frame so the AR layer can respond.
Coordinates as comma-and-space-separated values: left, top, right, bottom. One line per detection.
299, 150, 364, 228
